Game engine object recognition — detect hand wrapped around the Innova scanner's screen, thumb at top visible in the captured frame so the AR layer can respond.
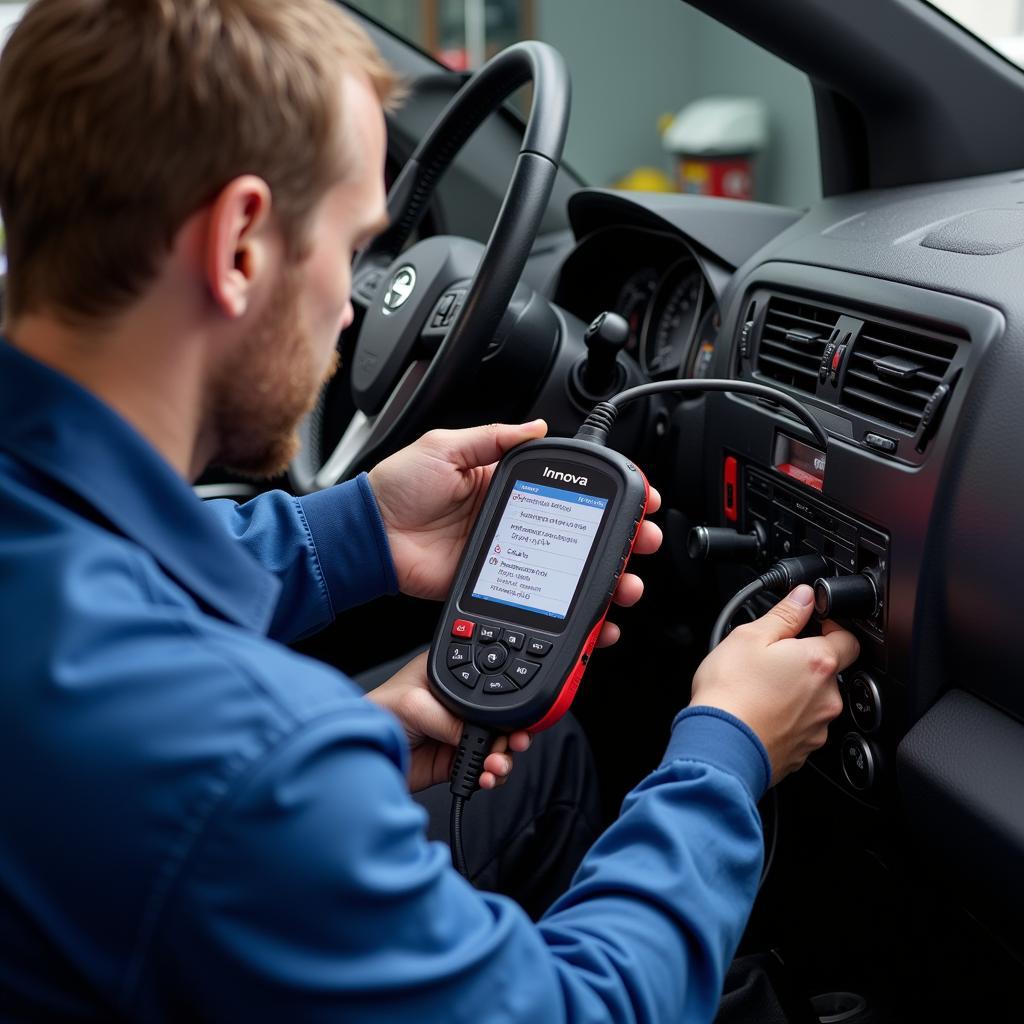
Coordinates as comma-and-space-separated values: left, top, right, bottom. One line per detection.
370, 420, 662, 647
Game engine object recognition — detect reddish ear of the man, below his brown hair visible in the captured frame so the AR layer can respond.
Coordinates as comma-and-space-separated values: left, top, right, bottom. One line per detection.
205, 174, 275, 319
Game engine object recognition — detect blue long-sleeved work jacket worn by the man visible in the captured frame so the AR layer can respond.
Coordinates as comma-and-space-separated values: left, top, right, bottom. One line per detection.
0, 341, 770, 1024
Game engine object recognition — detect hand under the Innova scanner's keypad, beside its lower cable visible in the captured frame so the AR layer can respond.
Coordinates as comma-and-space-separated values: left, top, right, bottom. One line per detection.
367, 652, 530, 793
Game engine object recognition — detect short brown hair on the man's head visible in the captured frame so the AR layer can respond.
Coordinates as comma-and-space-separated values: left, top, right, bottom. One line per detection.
0, 0, 394, 322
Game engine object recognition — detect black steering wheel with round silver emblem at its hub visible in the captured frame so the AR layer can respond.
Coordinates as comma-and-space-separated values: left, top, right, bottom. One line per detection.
289, 42, 571, 494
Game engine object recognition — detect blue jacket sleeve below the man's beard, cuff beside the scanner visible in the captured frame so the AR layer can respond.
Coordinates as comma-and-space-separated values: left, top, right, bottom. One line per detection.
206, 473, 398, 643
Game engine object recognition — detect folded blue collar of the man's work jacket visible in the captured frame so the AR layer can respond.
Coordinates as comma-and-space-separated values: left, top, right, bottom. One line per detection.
0, 337, 281, 632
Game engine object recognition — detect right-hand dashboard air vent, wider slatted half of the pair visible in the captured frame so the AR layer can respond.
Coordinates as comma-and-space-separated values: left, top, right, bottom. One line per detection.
840, 321, 957, 434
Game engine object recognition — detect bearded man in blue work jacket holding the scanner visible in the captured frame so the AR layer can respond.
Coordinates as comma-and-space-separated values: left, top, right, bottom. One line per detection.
0, 0, 856, 1021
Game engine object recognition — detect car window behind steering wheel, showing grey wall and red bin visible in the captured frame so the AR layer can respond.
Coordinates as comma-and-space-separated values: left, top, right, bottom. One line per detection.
350, 0, 821, 206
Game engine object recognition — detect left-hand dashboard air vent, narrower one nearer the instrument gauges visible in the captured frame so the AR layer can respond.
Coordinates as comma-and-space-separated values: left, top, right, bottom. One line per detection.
758, 295, 840, 394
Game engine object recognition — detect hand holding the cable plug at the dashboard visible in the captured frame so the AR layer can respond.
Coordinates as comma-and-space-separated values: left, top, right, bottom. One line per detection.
691, 586, 860, 784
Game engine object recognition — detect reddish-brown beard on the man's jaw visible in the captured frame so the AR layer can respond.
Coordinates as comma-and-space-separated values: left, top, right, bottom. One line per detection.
211, 269, 339, 478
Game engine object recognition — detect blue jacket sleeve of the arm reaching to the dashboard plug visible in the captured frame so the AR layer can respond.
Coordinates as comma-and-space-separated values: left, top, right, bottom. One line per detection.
140, 709, 768, 1024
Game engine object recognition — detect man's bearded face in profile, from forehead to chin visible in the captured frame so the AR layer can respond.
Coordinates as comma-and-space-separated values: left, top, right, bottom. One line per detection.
213, 76, 387, 476
